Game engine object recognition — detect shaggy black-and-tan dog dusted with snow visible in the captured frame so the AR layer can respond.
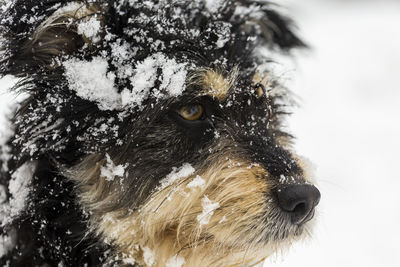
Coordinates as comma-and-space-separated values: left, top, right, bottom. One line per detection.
0, 0, 320, 266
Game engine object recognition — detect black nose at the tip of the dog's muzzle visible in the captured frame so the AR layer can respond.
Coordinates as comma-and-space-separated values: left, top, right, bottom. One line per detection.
276, 184, 321, 224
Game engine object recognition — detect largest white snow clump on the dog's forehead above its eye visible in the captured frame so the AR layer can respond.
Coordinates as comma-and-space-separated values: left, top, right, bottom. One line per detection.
63, 52, 187, 110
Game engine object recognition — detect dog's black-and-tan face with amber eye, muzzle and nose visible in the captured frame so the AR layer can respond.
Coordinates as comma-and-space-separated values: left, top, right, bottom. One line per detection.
69, 71, 319, 266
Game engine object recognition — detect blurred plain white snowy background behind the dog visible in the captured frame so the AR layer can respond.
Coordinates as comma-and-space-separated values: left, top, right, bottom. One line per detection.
0, 0, 400, 267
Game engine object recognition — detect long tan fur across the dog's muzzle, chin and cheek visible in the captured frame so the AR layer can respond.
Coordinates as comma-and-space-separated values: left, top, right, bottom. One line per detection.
65, 152, 294, 266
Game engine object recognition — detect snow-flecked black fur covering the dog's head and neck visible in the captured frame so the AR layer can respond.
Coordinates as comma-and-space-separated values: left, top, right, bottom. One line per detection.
0, 0, 304, 266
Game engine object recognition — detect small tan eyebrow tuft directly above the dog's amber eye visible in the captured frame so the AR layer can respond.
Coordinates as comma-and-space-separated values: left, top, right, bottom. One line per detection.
188, 67, 238, 101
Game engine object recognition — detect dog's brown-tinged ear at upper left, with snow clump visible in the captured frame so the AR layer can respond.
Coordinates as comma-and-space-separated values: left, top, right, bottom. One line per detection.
0, 1, 102, 77
